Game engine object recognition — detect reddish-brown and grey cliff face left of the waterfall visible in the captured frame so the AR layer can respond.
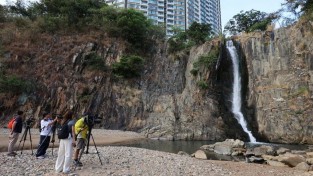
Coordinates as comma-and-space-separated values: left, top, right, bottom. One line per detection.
0, 28, 244, 140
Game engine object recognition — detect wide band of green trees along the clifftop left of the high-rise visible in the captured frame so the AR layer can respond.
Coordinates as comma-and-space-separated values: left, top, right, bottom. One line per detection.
5, 0, 165, 53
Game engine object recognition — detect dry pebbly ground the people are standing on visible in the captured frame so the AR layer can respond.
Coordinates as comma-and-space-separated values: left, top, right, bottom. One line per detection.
0, 129, 313, 176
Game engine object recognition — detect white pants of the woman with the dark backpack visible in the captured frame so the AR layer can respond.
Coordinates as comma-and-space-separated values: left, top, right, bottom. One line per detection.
55, 137, 73, 172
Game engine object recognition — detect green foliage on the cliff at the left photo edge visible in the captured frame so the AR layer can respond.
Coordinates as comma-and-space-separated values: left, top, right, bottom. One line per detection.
0, 75, 36, 94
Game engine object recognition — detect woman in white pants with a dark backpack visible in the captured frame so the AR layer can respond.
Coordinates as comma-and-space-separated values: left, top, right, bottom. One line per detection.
55, 111, 75, 174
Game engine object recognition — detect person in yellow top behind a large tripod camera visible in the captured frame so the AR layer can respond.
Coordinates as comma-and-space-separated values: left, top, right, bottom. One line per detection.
74, 115, 88, 166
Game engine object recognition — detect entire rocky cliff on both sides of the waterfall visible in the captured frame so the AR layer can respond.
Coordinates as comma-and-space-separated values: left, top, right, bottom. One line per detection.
0, 20, 313, 144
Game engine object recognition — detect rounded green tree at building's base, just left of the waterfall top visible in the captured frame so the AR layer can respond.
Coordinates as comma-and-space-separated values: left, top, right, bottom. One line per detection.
186, 22, 212, 44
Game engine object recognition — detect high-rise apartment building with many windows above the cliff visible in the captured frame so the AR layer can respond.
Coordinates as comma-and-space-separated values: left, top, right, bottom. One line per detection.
106, 0, 222, 36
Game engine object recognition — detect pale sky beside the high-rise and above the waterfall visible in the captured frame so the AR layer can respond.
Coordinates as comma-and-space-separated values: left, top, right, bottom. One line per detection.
0, 0, 285, 27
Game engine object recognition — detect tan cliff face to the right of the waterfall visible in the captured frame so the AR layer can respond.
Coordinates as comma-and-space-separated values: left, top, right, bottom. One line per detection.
238, 23, 313, 143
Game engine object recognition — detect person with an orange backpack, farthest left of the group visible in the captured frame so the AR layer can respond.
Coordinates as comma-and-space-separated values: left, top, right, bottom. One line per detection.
8, 111, 24, 156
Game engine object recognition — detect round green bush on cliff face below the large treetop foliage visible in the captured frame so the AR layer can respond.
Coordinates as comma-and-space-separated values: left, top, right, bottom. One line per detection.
112, 55, 144, 78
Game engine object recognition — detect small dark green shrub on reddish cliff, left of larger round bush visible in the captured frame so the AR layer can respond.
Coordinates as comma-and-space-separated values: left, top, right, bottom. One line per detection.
85, 52, 108, 71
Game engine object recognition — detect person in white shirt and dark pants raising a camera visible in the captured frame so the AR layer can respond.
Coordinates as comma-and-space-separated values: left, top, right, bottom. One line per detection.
36, 112, 56, 159
